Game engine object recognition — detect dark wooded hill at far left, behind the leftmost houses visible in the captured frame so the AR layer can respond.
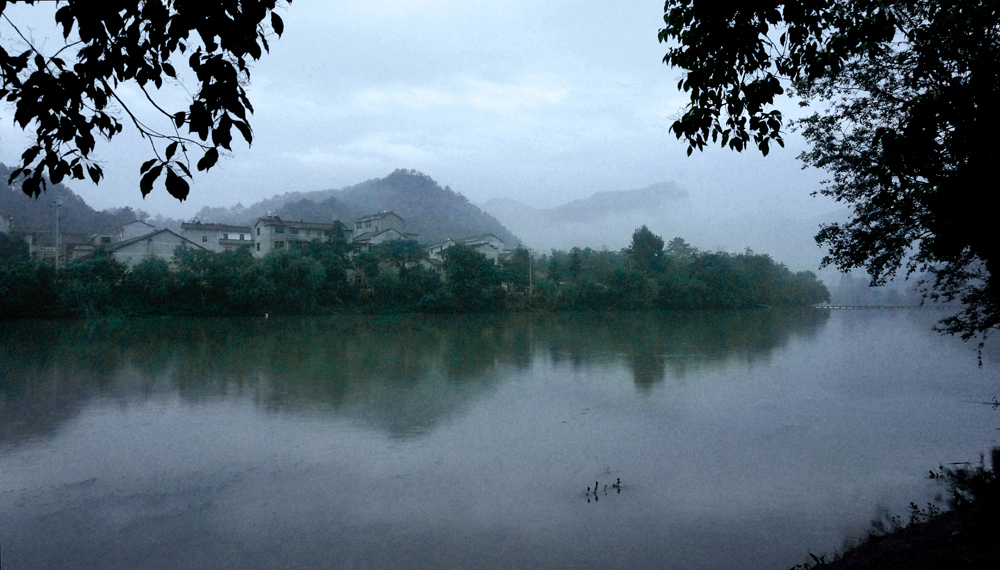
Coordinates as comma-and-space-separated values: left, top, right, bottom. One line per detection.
0, 163, 137, 235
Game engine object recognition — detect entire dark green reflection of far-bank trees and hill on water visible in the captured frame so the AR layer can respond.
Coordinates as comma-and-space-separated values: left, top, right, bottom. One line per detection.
0, 311, 827, 442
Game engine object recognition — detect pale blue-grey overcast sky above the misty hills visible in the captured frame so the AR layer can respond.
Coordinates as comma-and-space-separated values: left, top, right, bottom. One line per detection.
0, 0, 835, 221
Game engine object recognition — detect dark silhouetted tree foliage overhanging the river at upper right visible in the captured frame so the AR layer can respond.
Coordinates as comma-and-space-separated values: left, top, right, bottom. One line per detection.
660, 0, 1000, 339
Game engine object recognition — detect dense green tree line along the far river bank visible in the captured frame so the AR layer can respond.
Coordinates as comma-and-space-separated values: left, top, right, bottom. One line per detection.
0, 226, 829, 318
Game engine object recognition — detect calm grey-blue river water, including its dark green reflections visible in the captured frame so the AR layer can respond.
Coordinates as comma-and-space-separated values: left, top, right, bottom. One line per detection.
0, 311, 1000, 570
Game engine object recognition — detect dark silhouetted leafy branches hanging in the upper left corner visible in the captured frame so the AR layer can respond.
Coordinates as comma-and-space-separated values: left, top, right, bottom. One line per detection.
0, 0, 291, 200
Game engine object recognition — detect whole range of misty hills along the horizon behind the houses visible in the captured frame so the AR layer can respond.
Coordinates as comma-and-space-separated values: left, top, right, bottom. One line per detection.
0, 161, 846, 281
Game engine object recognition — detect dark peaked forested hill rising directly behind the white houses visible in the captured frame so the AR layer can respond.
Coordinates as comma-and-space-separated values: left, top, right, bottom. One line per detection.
196, 170, 520, 247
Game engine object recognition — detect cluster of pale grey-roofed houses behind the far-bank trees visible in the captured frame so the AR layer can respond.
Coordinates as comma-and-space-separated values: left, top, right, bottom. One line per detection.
0, 210, 510, 267
